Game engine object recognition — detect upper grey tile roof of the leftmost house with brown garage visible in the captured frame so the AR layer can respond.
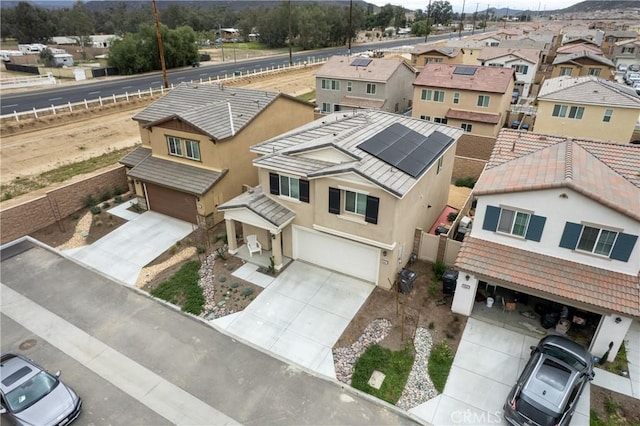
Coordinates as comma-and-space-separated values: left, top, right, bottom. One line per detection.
133, 83, 294, 140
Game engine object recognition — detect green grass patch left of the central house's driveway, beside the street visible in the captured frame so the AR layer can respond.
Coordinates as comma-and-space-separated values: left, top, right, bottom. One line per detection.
151, 260, 205, 315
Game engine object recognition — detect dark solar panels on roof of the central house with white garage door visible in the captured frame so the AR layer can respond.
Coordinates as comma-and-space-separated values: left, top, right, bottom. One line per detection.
358, 123, 453, 178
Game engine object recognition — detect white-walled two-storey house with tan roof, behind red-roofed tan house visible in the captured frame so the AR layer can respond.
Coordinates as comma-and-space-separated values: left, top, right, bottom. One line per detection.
478, 47, 541, 97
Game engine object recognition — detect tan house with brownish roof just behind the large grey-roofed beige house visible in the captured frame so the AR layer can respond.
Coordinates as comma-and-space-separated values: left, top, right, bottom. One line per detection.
551, 51, 615, 79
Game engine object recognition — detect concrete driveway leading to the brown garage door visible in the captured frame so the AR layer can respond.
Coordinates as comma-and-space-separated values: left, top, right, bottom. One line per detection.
65, 211, 193, 285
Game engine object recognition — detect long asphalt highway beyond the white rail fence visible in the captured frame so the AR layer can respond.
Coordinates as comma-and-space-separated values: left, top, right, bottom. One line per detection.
0, 33, 476, 116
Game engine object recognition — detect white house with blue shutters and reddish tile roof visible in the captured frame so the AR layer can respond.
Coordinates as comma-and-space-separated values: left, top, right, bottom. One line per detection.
451, 129, 640, 361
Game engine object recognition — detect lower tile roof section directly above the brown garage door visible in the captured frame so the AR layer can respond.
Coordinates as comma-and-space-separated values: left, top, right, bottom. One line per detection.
127, 156, 227, 195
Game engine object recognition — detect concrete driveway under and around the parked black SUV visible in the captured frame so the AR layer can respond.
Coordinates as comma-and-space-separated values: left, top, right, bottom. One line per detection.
409, 318, 590, 425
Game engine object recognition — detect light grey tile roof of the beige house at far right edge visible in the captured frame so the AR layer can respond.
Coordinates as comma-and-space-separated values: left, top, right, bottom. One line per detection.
538, 76, 640, 108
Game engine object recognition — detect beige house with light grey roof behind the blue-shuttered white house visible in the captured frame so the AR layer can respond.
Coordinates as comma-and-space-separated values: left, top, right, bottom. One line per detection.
533, 76, 640, 143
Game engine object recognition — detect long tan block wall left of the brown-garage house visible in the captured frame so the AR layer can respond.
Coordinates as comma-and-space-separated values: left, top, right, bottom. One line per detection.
0, 165, 128, 244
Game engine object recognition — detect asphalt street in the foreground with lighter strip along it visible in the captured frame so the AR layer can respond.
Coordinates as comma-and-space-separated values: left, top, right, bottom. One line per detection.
0, 241, 416, 425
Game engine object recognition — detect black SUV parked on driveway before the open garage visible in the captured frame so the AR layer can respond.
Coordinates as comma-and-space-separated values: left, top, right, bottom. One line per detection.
503, 336, 594, 426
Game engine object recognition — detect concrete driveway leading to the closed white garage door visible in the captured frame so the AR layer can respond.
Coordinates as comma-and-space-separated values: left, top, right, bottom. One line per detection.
213, 261, 374, 379
